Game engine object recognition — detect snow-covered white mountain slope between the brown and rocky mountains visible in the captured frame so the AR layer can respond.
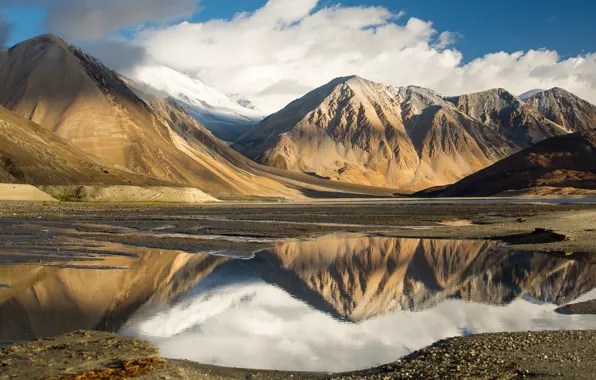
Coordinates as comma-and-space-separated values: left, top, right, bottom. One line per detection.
123, 62, 265, 141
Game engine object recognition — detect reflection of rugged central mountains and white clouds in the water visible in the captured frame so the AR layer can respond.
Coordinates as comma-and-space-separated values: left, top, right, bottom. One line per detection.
121, 235, 596, 371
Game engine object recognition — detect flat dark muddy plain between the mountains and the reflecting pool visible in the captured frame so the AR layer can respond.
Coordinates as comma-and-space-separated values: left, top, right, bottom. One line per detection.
0, 201, 596, 254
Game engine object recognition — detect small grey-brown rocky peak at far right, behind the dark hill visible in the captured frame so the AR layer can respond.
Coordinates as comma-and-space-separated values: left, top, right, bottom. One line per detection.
528, 87, 596, 132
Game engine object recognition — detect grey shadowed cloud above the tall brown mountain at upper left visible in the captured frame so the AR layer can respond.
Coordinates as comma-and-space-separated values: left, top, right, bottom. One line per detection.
0, 0, 198, 40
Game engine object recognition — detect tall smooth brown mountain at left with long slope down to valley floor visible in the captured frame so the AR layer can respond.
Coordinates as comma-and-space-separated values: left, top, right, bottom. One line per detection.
0, 35, 391, 199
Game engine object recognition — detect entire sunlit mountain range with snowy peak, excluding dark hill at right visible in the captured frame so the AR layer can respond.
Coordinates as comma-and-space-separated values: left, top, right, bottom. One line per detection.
0, 35, 596, 199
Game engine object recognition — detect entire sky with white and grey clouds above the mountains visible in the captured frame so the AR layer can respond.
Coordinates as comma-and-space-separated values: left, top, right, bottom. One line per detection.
0, 0, 596, 112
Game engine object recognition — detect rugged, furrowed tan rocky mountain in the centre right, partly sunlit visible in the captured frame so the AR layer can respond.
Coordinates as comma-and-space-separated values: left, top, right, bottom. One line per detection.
234, 77, 592, 191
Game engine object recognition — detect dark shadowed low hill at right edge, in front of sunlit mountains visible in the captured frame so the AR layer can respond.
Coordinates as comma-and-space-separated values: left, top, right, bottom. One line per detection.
440, 129, 596, 197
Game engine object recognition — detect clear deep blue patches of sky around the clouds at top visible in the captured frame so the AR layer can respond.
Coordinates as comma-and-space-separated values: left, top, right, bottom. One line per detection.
0, 0, 596, 61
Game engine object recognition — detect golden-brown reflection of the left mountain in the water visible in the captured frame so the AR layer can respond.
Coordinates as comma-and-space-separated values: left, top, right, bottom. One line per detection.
0, 245, 226, 341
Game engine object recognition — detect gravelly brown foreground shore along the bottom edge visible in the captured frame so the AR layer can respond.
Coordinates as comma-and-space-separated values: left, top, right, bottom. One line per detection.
0, 331, 596, 380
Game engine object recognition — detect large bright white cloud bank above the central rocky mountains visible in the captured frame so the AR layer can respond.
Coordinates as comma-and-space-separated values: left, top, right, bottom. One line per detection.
102, 0, 596, 112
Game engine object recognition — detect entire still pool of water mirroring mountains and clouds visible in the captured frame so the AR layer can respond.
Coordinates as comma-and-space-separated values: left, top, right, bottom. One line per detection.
0, 234, 596, 371
